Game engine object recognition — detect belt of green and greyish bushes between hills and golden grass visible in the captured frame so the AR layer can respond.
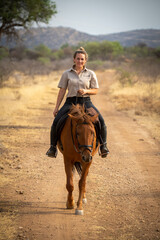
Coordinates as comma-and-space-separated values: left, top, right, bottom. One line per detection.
0, 41, 160, 81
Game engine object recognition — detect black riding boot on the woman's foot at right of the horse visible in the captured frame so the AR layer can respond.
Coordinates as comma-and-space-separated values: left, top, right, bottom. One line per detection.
100, 126, 109, 158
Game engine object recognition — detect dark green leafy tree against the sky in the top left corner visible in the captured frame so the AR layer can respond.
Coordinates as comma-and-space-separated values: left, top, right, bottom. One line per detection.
0, 0, 57, 38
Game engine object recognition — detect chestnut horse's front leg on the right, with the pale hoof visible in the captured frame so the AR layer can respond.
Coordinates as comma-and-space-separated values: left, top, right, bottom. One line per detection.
75, 164, 89, 215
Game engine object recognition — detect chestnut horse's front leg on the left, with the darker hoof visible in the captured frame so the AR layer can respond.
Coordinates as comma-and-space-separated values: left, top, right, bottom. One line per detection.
65, 161, 74, 209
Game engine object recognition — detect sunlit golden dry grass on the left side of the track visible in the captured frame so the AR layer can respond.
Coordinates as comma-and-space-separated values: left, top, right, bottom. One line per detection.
0, 71, 61, 125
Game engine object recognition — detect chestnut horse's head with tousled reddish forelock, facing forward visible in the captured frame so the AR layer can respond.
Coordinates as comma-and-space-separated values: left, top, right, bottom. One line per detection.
69, 106, 98, 163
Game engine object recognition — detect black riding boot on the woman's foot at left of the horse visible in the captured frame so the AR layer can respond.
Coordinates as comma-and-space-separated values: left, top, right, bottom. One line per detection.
46, 125, 58, 158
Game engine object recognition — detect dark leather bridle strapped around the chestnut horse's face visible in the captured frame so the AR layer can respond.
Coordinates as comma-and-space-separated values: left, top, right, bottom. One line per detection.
71, 119, 94, 155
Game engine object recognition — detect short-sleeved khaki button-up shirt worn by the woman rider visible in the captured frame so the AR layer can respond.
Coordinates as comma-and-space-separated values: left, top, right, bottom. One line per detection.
58, 67, 99, 97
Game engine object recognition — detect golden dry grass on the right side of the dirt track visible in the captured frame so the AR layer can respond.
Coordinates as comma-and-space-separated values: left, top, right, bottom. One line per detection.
110, 71, 160, 141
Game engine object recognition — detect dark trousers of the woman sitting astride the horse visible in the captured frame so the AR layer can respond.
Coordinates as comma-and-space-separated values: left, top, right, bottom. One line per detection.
51, 97, 107, 146
